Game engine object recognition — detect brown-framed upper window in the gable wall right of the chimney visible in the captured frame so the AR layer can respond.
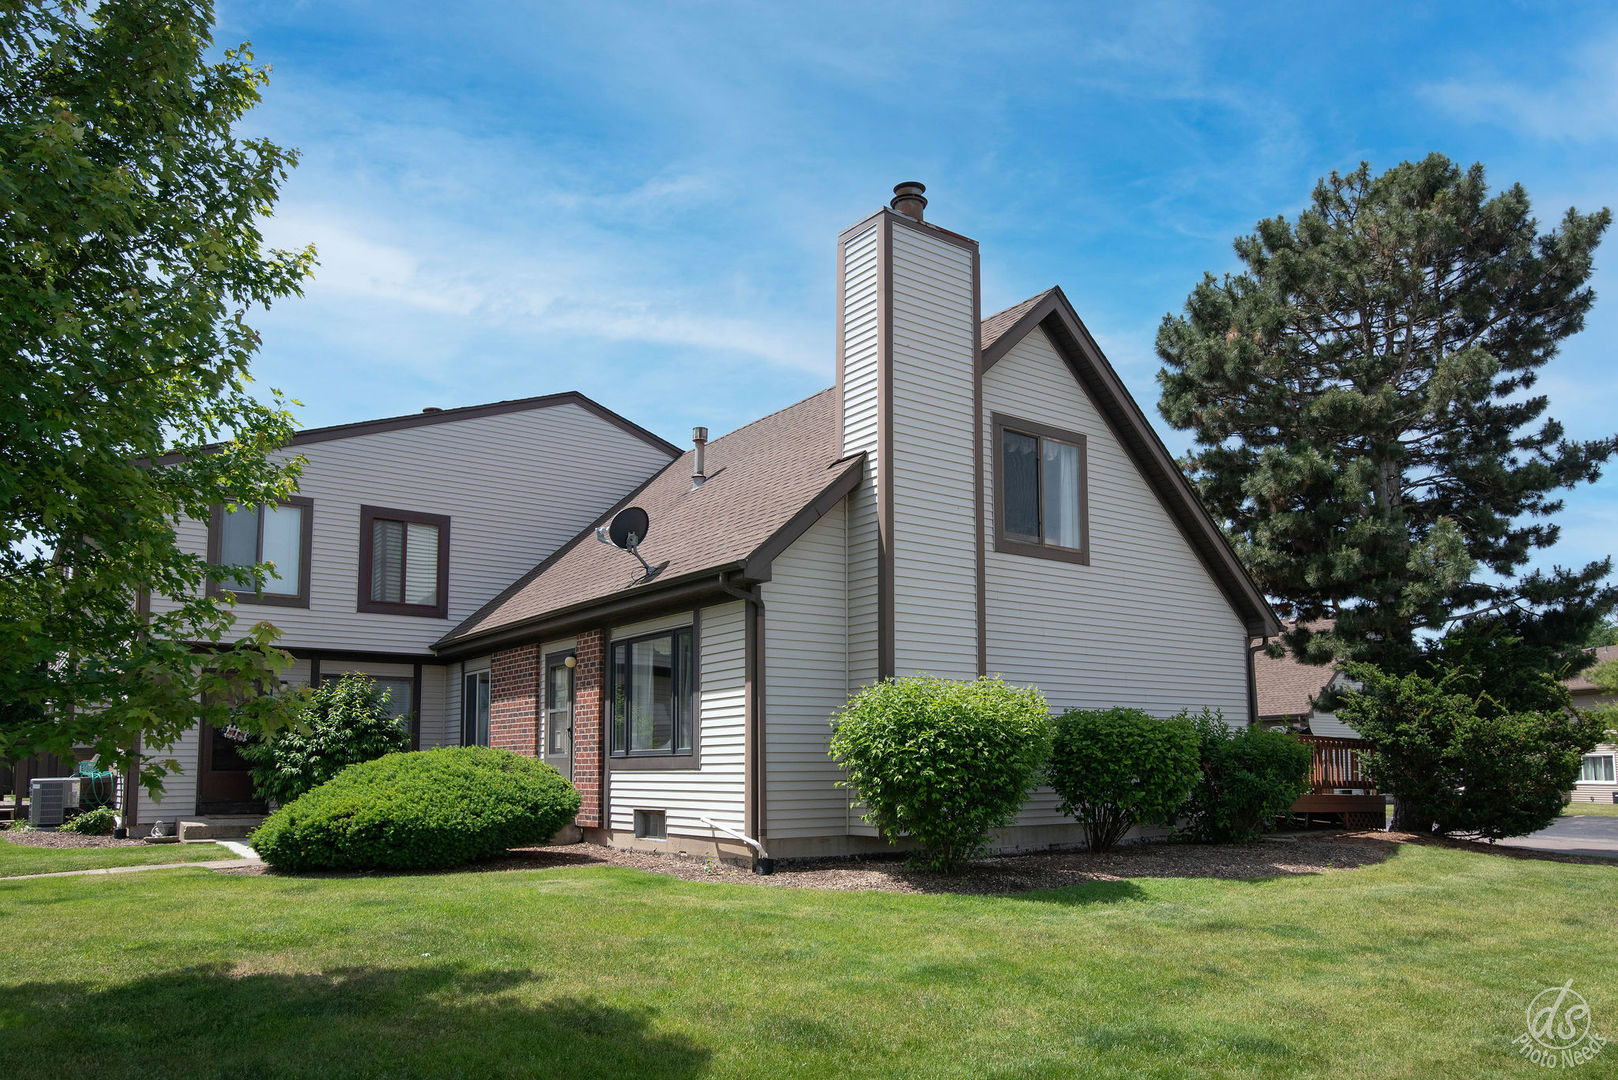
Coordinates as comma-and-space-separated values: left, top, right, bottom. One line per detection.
993, 415, 1091, 563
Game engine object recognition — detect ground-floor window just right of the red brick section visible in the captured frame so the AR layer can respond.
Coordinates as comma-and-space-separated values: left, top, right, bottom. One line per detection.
612, 627, 696, 756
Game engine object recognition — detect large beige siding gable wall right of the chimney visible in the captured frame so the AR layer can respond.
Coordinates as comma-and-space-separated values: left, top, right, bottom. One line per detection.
982, 330, 1247, 824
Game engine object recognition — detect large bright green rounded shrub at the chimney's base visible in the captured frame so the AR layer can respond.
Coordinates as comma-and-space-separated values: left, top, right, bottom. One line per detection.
832, 675, 1050, 870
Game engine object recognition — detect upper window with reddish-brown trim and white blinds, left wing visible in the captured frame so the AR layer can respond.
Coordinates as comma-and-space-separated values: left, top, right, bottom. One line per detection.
356, 507, 450, 619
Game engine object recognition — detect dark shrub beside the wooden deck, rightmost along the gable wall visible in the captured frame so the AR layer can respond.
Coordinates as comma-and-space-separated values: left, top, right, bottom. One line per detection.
1184, 709, 1314, 844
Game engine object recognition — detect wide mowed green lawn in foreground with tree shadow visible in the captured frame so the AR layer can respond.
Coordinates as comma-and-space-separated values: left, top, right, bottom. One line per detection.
0, 847, 1618, 1080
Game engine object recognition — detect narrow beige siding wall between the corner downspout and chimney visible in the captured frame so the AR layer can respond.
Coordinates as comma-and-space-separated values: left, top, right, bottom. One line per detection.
764, 505, 848, 839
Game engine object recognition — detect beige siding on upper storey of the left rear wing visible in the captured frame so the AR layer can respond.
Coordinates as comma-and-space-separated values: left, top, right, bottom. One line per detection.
142, 403, 668, 654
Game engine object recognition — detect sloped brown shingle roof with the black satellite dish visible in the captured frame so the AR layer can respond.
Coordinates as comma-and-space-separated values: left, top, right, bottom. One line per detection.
437, 389, 864, 648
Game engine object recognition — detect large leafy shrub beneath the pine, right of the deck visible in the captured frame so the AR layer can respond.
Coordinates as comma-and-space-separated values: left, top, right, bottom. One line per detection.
1338, 664, 1605, 840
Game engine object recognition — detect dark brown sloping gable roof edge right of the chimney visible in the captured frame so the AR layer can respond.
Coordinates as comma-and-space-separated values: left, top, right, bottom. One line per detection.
977, 287, 1280, 636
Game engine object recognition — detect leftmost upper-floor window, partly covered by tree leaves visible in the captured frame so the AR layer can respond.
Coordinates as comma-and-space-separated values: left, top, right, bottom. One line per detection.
207, 497, 314, 607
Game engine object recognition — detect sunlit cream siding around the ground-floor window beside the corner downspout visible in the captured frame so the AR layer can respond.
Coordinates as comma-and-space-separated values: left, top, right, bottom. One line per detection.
607, 601, 746, 839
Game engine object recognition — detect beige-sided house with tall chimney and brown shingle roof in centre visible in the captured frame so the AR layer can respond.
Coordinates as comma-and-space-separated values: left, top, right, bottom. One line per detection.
132, 185, 1280, 857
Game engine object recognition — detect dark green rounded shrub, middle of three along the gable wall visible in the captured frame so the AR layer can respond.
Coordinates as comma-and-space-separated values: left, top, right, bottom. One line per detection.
1045, 709, 1202, 852
